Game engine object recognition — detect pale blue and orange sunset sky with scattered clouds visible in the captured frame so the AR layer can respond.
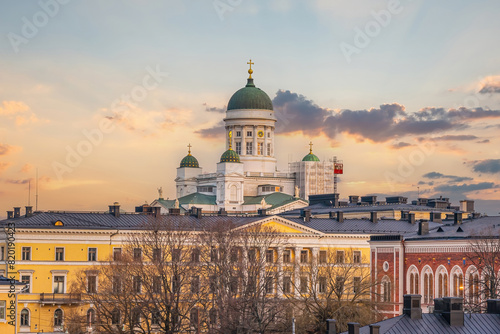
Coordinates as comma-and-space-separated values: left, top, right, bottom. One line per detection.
0, 0, 500, 218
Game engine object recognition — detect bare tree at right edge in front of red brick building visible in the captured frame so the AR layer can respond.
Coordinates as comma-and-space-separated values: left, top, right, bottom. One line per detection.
464, 229, 500, 312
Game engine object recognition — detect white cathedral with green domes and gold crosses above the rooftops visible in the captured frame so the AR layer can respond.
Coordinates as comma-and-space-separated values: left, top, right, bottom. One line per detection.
152, 61, 340, 213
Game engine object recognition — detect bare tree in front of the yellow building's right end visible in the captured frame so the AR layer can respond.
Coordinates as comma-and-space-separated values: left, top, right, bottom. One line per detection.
288, 249, 376, 333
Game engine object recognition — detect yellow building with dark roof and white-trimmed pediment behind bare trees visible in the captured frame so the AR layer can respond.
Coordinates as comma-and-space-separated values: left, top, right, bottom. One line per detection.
0, 204, 426, 333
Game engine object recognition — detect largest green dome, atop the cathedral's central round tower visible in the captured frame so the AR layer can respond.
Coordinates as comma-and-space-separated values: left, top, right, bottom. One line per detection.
227, 78, 273, 110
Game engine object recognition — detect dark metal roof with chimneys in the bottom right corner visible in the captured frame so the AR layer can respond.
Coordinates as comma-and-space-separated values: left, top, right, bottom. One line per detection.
342, 313, 500, 334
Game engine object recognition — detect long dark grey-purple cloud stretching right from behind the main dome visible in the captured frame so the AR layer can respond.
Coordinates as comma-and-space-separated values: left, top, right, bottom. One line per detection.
198, 90, 500, 142
